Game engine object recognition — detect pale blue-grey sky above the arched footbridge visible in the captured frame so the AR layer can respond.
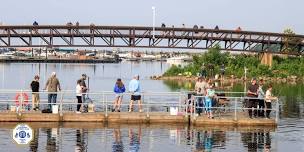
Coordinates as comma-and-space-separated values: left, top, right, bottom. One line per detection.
0, 0, 304, 35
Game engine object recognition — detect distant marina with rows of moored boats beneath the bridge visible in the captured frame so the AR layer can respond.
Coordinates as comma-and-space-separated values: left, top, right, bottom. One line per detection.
0, 48, 195, 65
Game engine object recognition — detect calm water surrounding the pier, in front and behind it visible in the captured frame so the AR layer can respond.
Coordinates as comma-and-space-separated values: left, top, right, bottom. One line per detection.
0, 62, 304, 152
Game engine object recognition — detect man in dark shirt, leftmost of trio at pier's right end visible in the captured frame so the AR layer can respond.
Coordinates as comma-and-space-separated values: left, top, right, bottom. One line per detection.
247, 78, 259, 118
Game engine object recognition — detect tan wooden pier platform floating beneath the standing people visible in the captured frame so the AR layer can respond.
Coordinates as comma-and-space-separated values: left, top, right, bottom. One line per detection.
0, 111, 277, 126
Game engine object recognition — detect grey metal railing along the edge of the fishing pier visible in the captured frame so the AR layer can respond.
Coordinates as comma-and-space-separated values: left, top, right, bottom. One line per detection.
0, 90, 279, 122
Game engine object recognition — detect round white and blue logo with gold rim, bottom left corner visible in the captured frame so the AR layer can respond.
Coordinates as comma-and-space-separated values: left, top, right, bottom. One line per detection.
13, 124, 33, 145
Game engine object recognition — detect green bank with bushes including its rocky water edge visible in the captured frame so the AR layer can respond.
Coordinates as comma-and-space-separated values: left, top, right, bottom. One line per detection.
151, 45, 304, 83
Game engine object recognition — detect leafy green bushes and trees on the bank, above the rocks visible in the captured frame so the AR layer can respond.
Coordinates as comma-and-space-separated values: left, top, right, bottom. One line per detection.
164, 46, 304, 78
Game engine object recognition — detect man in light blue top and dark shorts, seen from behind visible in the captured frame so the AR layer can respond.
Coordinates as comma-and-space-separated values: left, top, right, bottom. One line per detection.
129, 74, 142, 112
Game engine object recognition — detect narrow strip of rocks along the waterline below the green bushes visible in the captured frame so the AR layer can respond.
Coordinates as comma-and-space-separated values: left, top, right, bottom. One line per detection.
150, 75, 304, 83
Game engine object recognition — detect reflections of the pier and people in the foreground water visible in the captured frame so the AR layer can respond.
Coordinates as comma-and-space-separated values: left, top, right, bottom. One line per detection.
0, 123, 276, 152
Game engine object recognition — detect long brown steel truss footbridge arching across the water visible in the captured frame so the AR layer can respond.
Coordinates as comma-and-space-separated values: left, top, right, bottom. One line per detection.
0, 25, 304, 54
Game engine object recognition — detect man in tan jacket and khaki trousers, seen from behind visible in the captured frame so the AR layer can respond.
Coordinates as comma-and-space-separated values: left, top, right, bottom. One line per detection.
44, 72, 61, 109
